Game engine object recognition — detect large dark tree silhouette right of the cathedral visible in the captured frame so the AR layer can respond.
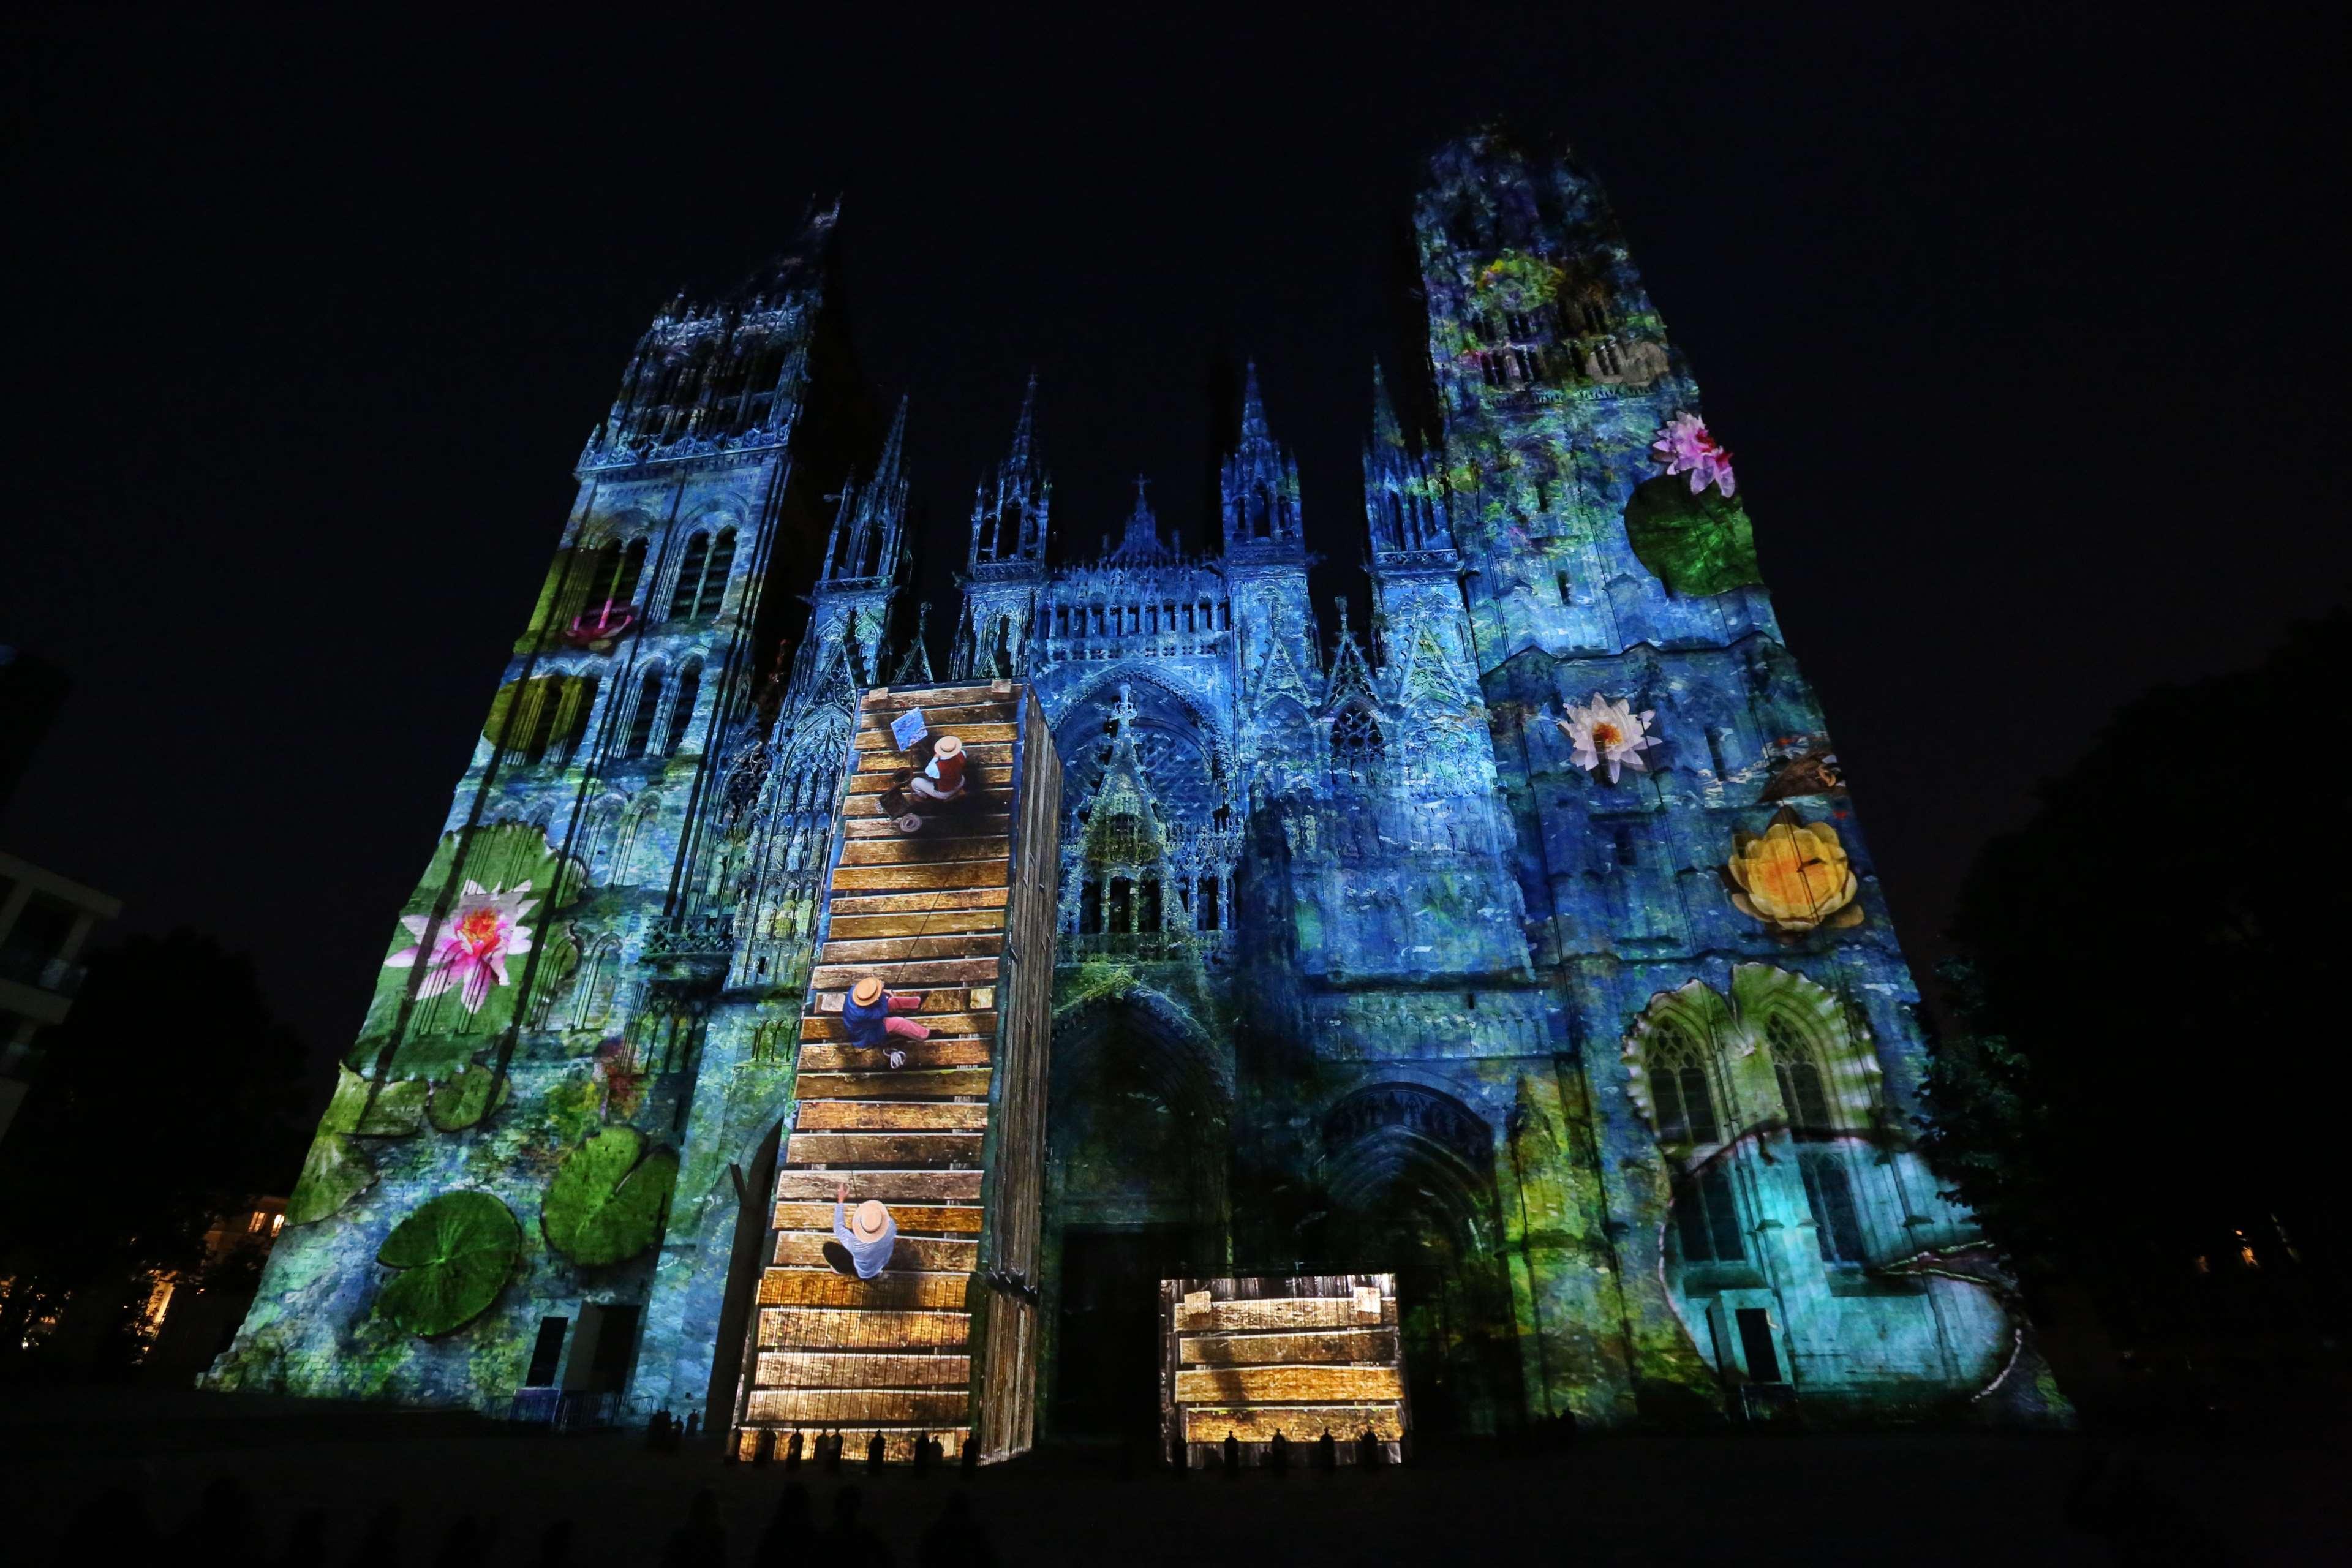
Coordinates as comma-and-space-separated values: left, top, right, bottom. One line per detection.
1926, 611, 2352, 1319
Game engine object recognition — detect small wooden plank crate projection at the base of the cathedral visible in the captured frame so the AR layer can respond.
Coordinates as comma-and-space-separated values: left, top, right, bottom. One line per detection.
1159, 1274, 1411, 1469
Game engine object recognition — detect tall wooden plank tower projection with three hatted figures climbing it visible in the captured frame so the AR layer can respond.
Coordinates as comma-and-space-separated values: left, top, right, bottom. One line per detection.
731, 682, 1061, 1462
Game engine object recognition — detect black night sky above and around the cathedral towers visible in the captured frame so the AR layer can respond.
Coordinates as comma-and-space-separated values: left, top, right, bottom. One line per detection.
0, 5, 2352, 1081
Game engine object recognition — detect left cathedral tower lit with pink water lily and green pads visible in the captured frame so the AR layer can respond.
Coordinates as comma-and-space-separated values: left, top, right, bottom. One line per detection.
212, 214, 905, 1413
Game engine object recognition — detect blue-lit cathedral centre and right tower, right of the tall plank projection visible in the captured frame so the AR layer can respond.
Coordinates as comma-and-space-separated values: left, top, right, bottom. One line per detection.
955, 137, 2056, 1430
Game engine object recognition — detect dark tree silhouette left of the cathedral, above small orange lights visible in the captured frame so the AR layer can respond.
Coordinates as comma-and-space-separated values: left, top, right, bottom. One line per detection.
0, 931, 303, 1366
